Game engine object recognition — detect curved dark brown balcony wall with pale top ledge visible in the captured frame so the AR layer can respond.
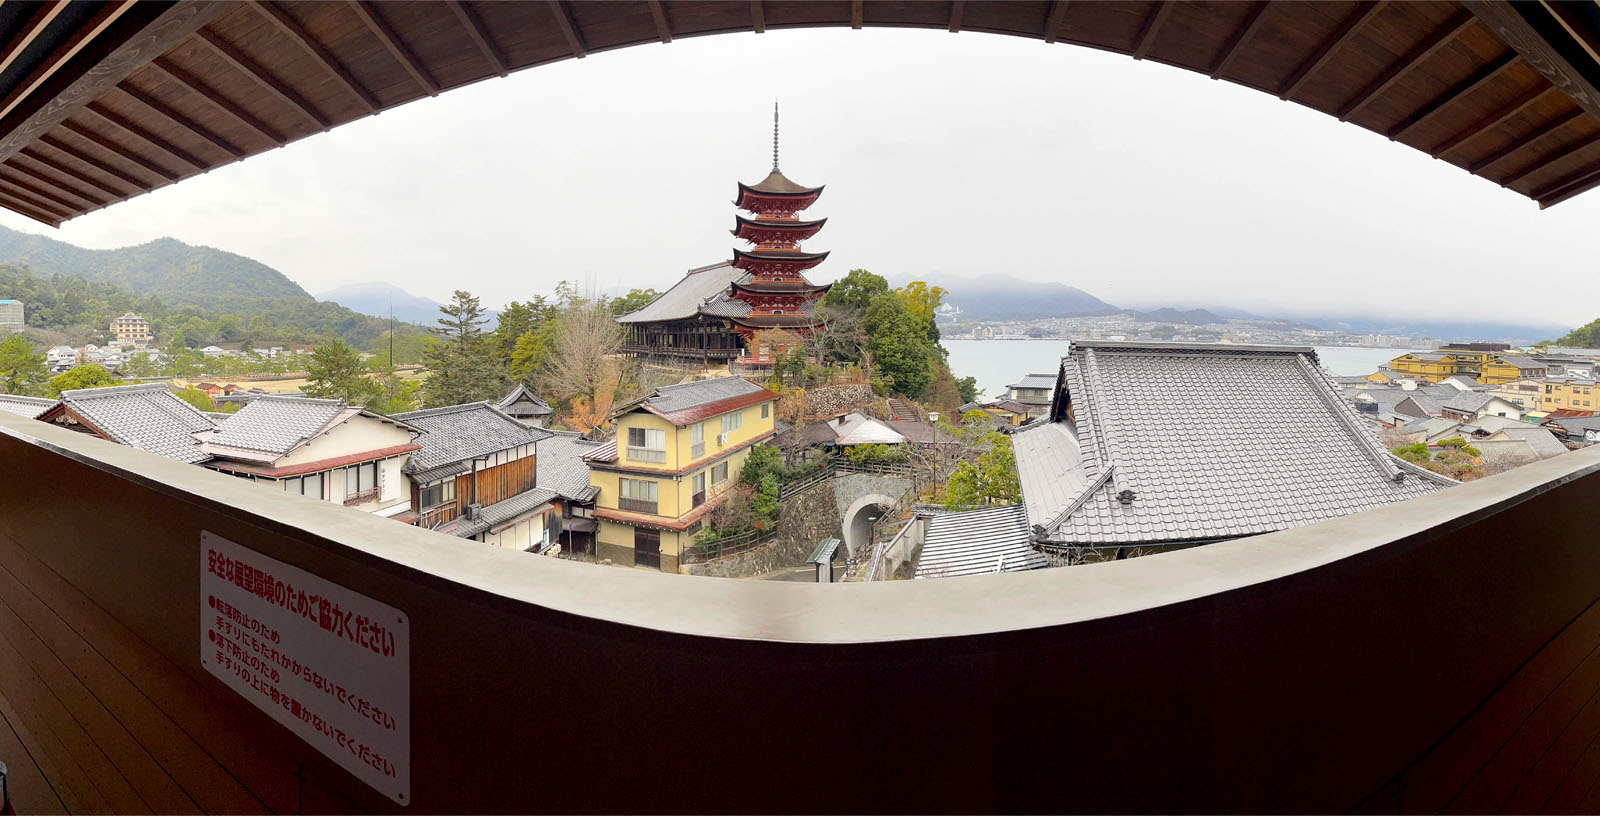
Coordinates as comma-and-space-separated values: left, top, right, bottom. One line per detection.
0, 414, 1600, 813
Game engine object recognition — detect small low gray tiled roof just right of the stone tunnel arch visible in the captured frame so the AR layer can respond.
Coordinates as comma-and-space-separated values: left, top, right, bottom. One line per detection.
917, 504, 1050, 578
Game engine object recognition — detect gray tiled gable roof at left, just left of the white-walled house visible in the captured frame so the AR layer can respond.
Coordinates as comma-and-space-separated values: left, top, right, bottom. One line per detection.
61, 382, 216, 464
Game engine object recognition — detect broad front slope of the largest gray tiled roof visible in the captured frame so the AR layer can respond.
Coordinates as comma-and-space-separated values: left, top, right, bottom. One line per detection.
1013, 342, 1453, 546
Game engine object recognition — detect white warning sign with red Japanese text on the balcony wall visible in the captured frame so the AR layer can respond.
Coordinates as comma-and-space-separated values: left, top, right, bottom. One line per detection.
200, 533, 411, 805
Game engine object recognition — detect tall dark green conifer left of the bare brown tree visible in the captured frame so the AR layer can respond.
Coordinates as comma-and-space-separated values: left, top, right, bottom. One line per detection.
422, 290, 504, 406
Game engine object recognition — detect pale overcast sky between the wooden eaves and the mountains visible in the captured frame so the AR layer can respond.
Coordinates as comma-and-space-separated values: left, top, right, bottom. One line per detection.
0, 29, 1600, 325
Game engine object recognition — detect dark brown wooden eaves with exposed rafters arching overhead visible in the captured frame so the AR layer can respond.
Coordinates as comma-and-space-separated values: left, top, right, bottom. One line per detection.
0, 0, 1600, 226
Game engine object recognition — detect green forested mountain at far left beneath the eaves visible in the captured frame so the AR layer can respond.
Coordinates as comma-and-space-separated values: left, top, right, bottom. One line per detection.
0, 227, 310, 310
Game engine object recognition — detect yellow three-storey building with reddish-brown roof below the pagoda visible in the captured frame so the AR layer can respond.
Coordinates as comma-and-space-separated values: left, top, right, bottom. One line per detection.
584, 378, 778, 573
